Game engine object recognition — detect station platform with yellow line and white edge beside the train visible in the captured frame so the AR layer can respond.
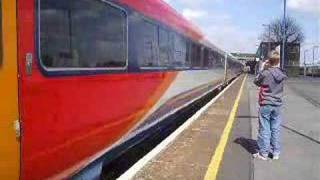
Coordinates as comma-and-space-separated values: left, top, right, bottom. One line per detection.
119, 75, 320, 180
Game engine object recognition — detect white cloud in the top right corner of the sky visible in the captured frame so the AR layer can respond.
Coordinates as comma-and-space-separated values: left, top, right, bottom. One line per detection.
288, 0, 320, 15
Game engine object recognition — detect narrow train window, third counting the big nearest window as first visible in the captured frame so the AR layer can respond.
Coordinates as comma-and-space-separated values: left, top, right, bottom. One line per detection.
159, 28, 172, 66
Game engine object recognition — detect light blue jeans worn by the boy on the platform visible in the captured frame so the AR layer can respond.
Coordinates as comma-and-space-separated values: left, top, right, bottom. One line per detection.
257, 105, 281, 157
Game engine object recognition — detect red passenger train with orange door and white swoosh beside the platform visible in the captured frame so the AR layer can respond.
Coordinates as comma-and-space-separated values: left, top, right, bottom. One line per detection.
0, 0, 243, 180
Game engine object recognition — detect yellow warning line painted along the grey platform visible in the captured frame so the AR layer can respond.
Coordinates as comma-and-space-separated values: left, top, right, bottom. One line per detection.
204, 75, 247, 180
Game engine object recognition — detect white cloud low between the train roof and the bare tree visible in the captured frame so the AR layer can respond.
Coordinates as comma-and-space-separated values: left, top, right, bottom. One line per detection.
182, 8, 258, 52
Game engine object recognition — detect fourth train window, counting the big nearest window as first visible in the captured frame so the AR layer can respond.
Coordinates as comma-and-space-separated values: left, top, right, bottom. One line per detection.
172, 33, 187, 67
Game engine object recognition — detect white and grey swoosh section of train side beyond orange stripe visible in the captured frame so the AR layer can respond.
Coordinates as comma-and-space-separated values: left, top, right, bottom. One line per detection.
130, 69, 223, 132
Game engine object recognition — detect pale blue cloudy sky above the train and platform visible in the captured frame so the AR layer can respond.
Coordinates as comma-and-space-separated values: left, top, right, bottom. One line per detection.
164, 0, 320, 63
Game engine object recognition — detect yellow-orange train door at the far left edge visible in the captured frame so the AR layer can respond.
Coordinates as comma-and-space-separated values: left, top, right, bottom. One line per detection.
0, 0, 20, 180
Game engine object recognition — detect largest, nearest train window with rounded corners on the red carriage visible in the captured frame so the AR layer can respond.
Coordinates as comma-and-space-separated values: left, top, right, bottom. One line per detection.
40, 0, 127, 70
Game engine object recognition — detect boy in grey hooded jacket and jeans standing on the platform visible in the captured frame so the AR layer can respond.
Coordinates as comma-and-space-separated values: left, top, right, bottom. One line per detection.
254, 51, 287, 160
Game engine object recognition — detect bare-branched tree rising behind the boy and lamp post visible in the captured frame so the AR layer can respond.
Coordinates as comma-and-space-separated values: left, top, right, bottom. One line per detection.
261, 17, 305, 43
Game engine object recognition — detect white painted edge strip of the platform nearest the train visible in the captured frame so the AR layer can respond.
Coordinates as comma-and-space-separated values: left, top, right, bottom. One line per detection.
117, 78, 241, 180
